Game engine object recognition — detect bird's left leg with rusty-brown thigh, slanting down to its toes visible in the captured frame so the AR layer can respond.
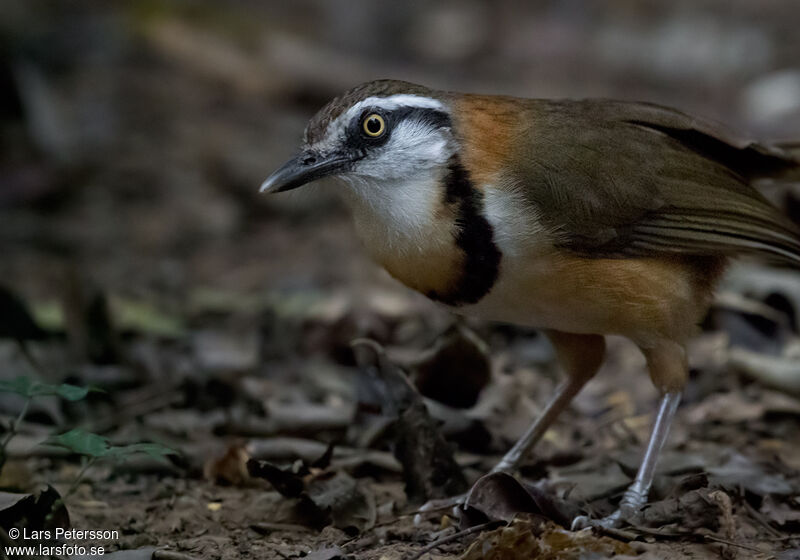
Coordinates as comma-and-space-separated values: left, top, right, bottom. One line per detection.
420, 331, 605, 512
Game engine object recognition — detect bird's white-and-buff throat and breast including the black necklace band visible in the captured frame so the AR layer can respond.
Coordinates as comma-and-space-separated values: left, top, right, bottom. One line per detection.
344, 157, 502, 307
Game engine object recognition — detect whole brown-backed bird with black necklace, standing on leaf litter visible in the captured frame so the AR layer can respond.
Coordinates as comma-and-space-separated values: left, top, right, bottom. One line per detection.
260, 80, 800, 529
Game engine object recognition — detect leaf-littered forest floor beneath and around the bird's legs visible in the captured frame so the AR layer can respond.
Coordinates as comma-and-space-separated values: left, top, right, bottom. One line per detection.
0, 208, 800, 560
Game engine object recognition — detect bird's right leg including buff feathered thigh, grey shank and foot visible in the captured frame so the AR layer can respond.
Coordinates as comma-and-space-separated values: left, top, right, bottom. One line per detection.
572, 343, 688, 530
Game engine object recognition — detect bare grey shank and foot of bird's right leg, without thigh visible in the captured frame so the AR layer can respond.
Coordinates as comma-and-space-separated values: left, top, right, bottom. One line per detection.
572, 392, 681, 530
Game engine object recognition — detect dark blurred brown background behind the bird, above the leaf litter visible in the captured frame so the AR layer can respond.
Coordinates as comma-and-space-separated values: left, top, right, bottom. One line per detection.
0, 0, 800, 316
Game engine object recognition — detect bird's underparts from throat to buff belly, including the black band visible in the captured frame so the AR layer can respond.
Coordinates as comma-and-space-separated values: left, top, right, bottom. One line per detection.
346, 173, 707, 345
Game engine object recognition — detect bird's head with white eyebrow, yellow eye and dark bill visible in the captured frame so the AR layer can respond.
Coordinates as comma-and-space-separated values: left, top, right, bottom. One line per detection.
261, 80, 456, 196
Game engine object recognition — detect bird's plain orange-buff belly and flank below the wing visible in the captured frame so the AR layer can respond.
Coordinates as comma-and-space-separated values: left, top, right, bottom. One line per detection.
453, 254, 705, 344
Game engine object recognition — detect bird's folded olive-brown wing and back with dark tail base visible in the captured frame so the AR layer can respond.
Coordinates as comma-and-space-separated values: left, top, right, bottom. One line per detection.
510, 101, 800, 265
